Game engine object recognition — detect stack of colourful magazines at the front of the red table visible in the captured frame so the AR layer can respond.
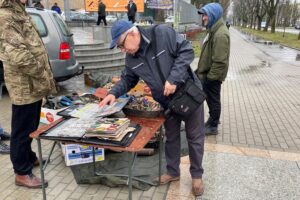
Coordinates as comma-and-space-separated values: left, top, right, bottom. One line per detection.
84, 118, 134, 141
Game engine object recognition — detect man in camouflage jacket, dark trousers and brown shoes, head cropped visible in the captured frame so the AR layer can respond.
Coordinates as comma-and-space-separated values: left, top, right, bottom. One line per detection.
0, 0, 56, 188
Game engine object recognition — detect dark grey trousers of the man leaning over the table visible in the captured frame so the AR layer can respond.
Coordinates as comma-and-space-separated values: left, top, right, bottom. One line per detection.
164, 105, 205, 178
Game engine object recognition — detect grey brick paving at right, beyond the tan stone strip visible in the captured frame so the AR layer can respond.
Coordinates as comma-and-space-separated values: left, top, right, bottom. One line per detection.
206, 29, 300, 153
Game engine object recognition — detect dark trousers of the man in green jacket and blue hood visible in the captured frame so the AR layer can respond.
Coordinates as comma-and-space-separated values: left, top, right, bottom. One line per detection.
201, 80, 222, 127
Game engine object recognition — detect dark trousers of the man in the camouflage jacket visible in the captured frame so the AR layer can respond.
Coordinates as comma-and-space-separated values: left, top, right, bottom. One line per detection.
10, 100, 42, 175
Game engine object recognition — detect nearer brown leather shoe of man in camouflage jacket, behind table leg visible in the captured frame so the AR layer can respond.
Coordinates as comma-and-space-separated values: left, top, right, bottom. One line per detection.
15, 174, 48, 188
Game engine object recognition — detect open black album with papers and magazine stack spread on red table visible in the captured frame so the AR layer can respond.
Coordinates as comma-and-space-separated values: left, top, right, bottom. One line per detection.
41, 97, 141, 146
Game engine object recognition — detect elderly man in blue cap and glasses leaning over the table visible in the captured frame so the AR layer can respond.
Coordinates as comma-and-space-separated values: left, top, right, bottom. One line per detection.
100, 20, 205, 196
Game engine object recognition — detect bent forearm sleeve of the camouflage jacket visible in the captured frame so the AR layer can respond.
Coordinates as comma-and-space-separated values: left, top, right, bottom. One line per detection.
0, 22, 44, 78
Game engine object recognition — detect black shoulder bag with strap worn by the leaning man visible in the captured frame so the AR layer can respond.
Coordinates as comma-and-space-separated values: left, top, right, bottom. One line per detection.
152, 26, 206, 117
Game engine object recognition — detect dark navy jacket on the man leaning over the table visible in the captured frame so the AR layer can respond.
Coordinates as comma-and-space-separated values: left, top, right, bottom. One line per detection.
109, 25, 202, 108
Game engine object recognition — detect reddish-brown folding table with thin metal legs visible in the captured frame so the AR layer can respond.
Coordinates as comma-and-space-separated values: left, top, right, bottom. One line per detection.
30, 117, 164, 200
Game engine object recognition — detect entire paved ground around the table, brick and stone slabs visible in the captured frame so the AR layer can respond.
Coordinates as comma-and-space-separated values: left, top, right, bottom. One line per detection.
0, 29, 300, 200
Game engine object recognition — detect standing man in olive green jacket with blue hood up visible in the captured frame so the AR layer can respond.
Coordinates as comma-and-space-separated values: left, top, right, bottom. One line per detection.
196, 3, 230, 135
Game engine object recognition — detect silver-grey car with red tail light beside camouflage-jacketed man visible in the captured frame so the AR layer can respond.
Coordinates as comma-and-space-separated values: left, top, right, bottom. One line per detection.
0, 8, 80, 82
